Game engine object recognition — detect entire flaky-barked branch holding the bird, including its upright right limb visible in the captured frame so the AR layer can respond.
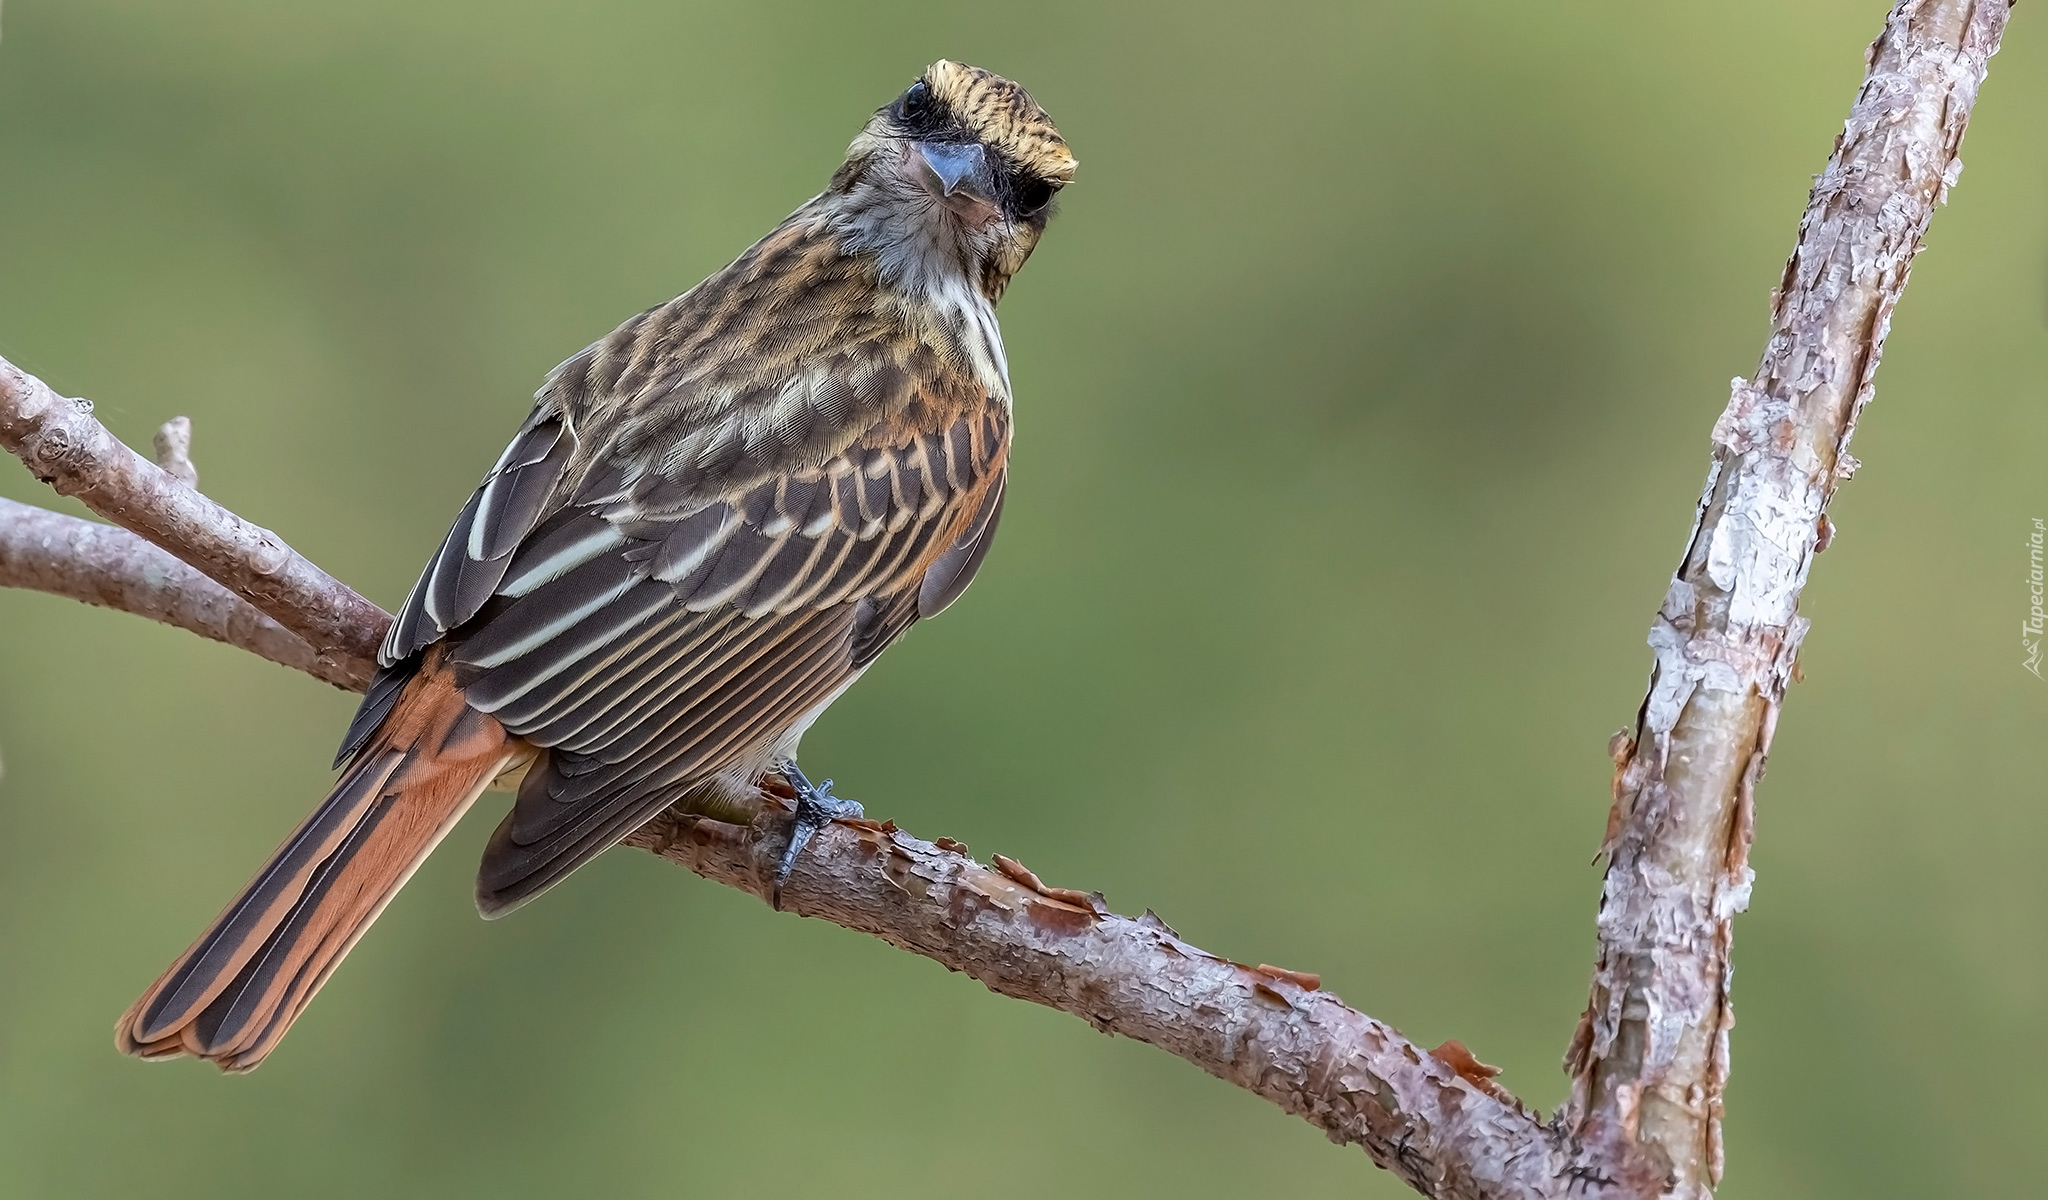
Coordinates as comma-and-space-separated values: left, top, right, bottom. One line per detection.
0, 0, 2011, 1200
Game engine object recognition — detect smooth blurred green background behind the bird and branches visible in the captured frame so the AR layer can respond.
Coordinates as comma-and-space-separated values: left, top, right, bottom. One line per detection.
0, 0, 2048, 1200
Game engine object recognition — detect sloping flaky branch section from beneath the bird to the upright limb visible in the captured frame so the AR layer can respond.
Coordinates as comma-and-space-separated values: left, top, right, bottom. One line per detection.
629, 803, 1572, 1200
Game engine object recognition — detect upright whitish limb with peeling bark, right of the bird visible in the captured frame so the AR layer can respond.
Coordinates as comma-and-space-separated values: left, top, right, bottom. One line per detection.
1565, 0, 2011, 1196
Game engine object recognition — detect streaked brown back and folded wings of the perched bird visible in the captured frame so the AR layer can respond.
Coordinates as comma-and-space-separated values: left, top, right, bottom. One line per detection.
344, 217, 1010, 911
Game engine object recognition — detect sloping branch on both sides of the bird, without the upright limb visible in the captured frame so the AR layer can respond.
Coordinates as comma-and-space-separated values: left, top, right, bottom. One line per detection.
0, 358, 1602, 1200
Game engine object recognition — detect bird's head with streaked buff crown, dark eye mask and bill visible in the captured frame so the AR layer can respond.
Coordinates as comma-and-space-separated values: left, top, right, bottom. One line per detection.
827, 59, 1073, 301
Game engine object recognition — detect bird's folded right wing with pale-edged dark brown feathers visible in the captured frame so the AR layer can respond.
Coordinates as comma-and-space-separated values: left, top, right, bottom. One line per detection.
455, 410, 1008, 911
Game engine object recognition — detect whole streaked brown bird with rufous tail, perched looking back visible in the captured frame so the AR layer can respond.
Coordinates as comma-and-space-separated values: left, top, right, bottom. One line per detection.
117, 59, 1075, 1071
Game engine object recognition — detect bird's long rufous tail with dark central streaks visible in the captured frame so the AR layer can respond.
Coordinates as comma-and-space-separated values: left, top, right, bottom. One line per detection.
115, 663, 512, 1071
